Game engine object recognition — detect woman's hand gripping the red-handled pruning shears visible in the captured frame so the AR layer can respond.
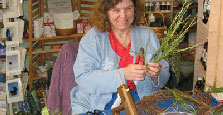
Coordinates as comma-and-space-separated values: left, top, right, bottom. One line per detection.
124, 64, 148, 81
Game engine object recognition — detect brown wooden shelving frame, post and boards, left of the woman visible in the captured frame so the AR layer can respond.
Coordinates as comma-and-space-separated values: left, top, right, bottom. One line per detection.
25, 0, 84, 89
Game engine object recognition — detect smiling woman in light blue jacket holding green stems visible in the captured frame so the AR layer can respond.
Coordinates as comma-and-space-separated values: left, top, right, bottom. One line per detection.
71, 0, 169, 114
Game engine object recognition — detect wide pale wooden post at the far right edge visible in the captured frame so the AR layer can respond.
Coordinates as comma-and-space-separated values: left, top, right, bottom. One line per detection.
206, 0, 223, 88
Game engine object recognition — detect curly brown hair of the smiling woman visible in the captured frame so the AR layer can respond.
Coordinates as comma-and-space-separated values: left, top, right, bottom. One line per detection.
91, 0, 144, 32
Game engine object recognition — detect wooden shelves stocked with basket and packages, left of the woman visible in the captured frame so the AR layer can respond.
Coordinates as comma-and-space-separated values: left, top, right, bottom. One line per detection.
26, 0, 89, 90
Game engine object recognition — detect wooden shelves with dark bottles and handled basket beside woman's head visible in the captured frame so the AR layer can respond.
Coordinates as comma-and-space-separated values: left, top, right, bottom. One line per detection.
144, 0, 173, 38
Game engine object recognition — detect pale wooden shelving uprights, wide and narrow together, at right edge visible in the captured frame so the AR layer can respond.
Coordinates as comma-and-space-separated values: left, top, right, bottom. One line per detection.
194, 0, 223, 89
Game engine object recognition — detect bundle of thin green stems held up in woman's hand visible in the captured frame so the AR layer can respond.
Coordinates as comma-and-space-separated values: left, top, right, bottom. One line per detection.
151, 2, 201, 62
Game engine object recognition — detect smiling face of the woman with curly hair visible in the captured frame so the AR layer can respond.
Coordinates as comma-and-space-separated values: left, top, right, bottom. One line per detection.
108, 0, 134, 31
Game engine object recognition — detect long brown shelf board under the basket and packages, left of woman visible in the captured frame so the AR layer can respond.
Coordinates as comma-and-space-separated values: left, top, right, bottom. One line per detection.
24, 33, 84, 42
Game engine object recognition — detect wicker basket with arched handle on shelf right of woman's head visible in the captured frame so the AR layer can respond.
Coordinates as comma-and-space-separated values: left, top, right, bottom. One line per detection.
145, 12, 167, 38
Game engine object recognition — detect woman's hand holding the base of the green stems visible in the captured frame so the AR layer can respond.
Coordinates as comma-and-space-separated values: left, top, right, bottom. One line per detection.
147, 62, 162, 78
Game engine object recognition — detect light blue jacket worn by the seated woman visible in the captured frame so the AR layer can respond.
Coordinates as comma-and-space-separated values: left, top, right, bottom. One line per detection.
71, 26, 169, 114
